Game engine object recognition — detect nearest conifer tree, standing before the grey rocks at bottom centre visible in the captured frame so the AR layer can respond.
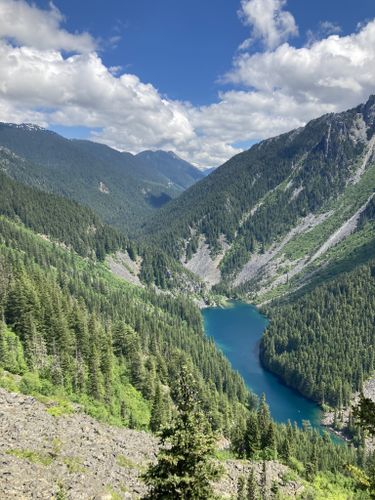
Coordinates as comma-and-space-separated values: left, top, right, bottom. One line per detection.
144, 366, 221, 500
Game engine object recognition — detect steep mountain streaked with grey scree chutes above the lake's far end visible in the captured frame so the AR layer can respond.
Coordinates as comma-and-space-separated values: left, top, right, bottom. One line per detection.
145, 96, 375, 302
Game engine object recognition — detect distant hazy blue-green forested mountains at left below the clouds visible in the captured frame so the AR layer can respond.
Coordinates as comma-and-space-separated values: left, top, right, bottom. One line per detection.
0, 123, 200, 231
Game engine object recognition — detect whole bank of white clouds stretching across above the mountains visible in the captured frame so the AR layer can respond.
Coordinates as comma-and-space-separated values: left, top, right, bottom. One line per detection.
0, 0, 375, 167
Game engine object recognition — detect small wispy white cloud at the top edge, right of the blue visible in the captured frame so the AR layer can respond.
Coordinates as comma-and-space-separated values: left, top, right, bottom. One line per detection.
239, 0, 298, 49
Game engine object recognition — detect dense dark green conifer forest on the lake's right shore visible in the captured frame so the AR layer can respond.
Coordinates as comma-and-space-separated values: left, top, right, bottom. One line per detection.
261, 261, 375, 407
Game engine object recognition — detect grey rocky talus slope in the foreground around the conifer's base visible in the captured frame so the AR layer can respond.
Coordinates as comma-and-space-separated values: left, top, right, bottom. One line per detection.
0, 388, 303, 500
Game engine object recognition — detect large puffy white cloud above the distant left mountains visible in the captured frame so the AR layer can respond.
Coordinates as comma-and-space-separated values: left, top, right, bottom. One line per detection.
0, 42, 193, 149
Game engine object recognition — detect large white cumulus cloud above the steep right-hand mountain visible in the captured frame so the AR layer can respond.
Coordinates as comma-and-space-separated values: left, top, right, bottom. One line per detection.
226, 21, 375, 106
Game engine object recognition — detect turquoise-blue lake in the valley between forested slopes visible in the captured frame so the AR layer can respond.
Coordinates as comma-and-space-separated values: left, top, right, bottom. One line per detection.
203, 302, 321, 428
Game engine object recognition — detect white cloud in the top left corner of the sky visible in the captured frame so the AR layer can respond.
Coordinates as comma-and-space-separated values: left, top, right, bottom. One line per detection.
0, 0, 95, 52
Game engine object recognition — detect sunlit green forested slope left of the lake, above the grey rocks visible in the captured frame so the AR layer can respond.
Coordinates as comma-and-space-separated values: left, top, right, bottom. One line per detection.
0, 218, 253, 432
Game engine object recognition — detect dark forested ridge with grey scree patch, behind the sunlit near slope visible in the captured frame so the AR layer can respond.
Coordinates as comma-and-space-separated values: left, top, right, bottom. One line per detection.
0, 167, 207, 292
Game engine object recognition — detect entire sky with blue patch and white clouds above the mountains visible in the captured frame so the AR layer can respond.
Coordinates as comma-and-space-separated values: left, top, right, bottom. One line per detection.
0, 0, 375, 168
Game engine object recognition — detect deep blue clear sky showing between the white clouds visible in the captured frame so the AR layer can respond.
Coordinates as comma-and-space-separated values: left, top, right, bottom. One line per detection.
31, 0, 375, 105
